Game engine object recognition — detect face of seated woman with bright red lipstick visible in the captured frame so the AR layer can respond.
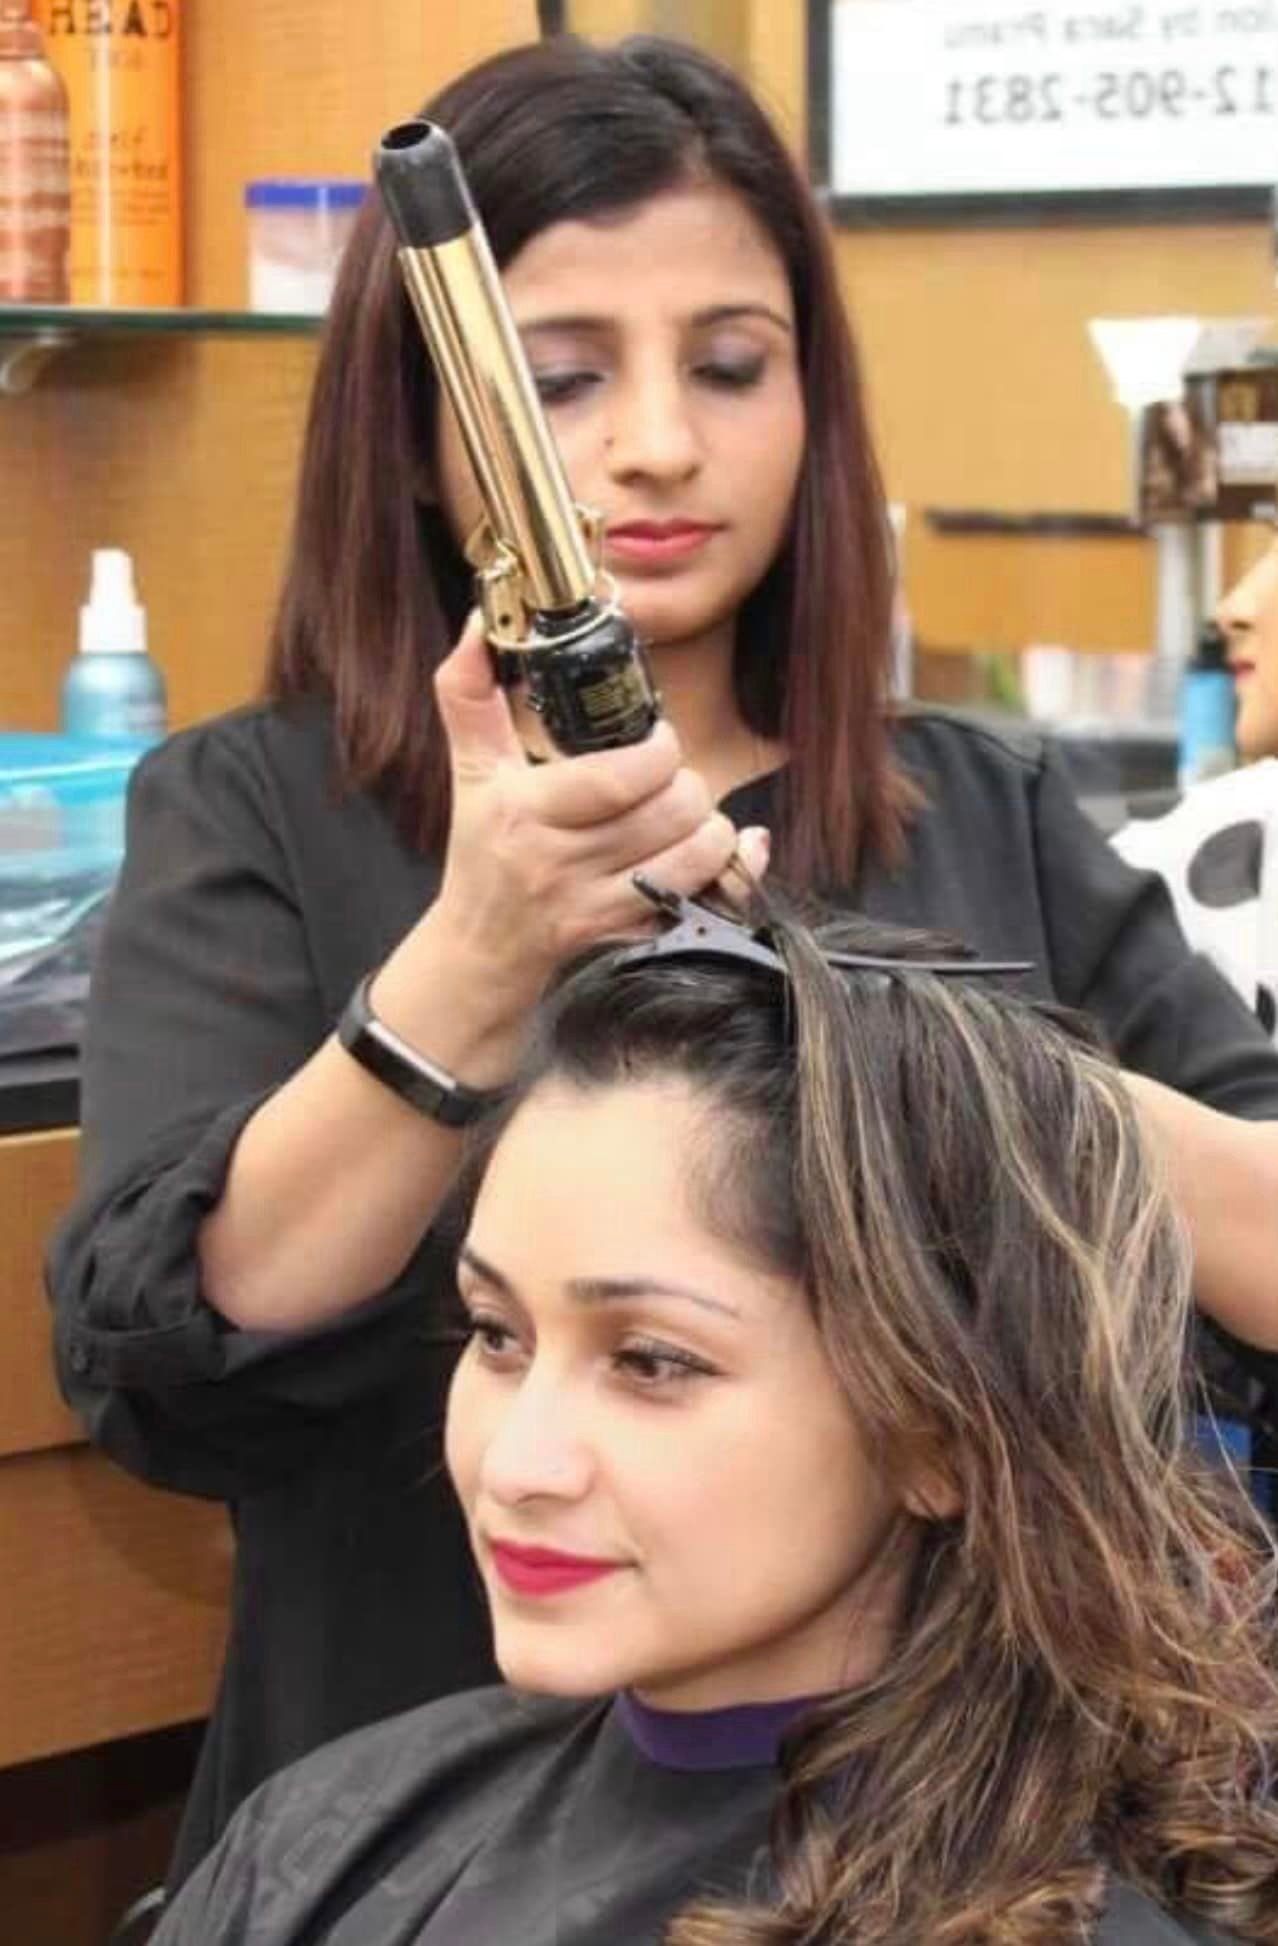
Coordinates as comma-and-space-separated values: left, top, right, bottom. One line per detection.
447, 1082, 905, 1709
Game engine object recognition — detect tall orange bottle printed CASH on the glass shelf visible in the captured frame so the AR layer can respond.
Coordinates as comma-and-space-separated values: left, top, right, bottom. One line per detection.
35, 0, 183, 309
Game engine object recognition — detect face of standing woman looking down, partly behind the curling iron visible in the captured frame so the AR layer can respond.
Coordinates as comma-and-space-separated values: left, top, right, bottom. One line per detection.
440, 185, 803, 669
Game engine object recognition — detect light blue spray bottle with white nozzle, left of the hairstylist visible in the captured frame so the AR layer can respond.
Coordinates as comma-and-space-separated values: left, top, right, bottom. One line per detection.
62, 547, 165, 738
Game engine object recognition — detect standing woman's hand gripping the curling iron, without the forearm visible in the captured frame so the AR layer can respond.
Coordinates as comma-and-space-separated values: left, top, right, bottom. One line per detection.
432, 617, 746, 1008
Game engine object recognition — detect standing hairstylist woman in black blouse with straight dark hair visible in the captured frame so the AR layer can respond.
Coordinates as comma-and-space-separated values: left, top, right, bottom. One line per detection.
51, 26, 1278, 1872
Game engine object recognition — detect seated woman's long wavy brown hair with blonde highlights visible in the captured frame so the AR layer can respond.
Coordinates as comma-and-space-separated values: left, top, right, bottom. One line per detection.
498, 926, 1278, 1946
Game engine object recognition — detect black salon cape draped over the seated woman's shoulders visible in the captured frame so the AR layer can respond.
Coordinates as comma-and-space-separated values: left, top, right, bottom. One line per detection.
152, 1689, 1212, 1946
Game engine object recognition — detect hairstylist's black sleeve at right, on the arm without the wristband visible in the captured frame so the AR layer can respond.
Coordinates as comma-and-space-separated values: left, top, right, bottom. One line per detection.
1035, 757, 1278, 1121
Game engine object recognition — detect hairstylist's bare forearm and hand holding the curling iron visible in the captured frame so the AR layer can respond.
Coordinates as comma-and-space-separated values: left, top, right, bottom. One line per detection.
200, 621, 766, 1331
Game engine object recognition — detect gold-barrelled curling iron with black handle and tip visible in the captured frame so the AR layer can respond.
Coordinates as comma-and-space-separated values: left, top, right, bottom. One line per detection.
373, 121, 661, 755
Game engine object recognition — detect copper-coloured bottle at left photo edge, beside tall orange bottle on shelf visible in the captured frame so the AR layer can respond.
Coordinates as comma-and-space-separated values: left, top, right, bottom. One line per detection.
0, 0, 70, 304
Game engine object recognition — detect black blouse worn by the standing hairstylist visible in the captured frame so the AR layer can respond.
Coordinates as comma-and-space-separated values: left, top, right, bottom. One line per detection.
51, 703, 1278, 1878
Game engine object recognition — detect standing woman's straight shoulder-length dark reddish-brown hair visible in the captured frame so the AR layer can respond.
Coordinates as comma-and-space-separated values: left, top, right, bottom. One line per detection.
268, 35, 908, 883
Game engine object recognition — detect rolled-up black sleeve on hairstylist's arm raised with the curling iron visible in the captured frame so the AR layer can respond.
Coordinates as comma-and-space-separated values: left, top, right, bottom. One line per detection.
49, 726, 457, 1498
